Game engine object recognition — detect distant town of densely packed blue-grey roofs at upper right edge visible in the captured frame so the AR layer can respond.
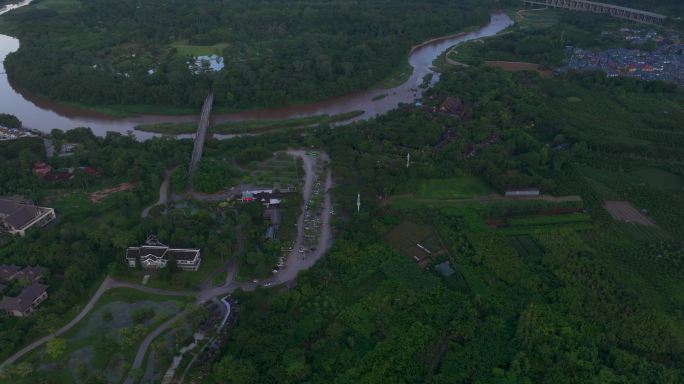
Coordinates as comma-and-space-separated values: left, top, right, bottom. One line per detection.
560, 28, 684, 85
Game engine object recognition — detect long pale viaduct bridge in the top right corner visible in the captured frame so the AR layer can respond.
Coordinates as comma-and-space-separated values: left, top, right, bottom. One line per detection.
523, 0, 667, 24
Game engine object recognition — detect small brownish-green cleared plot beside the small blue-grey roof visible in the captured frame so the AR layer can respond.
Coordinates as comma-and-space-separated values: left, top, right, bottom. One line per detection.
385, 221, 444, 267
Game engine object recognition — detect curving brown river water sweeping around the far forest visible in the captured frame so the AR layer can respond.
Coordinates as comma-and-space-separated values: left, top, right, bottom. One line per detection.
0, 7, 512, 140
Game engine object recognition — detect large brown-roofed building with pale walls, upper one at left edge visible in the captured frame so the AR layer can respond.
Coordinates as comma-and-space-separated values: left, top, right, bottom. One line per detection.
0, 198, 57, 236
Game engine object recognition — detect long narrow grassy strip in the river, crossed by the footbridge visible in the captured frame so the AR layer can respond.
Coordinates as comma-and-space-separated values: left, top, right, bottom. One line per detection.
135, 111, 365, 135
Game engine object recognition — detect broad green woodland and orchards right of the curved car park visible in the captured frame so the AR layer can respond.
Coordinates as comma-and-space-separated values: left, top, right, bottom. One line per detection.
205, 67, 684, 383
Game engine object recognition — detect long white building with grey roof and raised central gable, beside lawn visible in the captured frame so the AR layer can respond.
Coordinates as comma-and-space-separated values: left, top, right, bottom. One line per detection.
126, 235, 202, 272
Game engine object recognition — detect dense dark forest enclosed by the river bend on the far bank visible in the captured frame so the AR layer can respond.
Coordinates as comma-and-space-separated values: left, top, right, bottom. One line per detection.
0, 0, 491, 109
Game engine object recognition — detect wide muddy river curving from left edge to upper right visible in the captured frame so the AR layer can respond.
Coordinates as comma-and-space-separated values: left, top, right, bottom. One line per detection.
0, 4, 513, 140
